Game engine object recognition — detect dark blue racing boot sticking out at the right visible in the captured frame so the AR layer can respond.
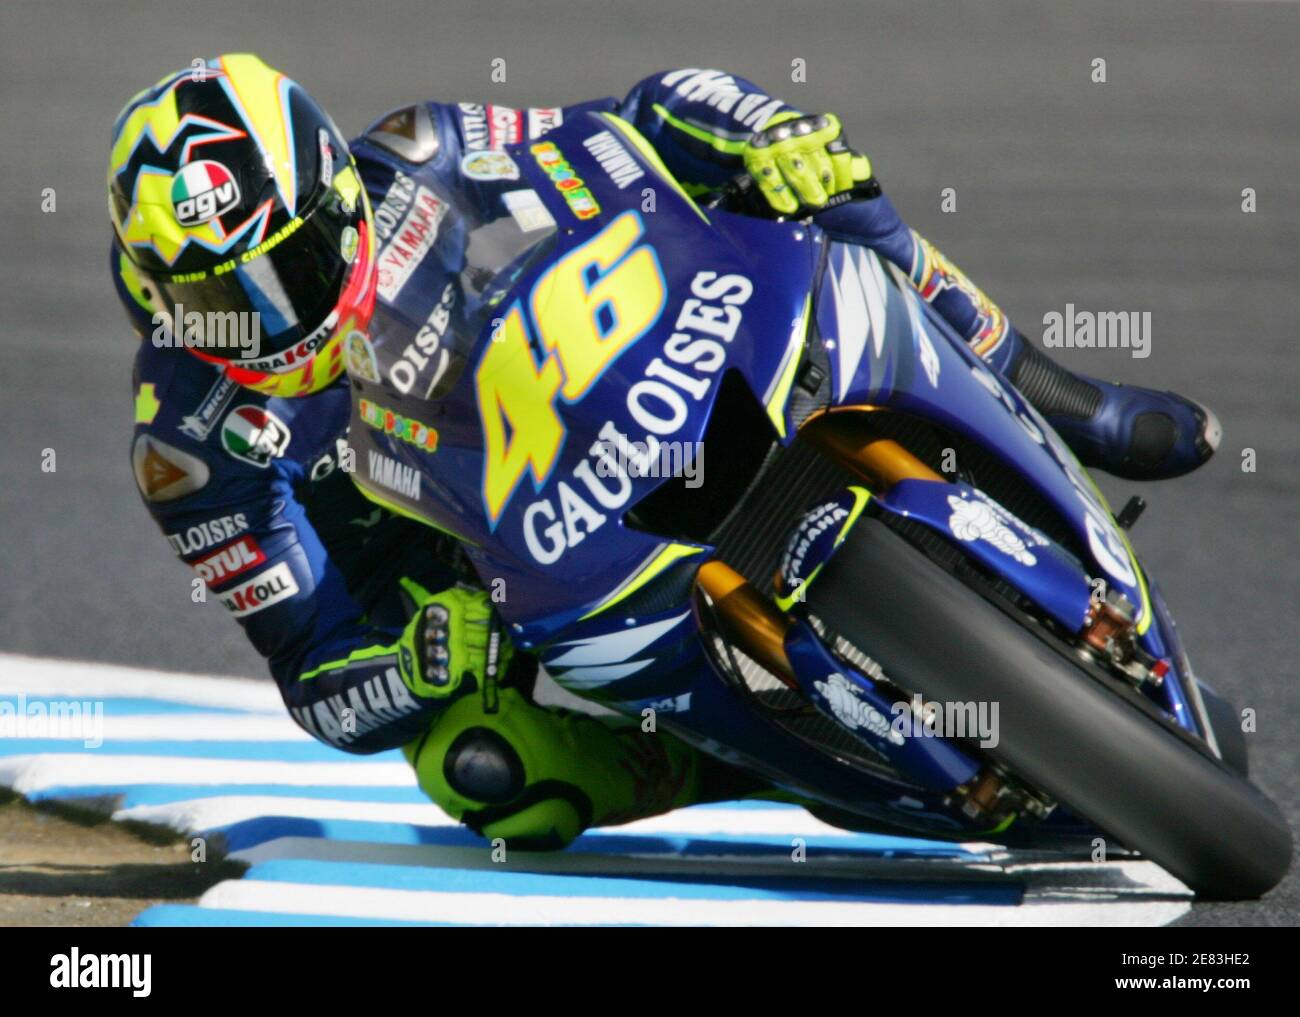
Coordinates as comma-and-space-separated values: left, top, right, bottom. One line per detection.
991, 329, 1222, 480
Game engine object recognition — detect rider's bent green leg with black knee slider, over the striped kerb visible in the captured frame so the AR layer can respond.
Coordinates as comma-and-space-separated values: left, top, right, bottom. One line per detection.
403, 688, 762, 851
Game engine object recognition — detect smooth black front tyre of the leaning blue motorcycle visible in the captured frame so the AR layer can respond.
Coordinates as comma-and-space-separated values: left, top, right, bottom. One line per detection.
807, 518, 1291, 900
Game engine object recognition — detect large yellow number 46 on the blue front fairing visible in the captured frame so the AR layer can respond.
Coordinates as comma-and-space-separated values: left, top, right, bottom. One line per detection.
475, 212, 667, 528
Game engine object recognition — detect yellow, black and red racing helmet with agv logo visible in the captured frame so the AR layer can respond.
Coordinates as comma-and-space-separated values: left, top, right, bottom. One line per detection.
108, 53, 376, 397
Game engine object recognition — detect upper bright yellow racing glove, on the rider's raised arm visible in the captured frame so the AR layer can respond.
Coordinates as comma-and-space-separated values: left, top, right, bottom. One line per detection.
744, 112, 871, 215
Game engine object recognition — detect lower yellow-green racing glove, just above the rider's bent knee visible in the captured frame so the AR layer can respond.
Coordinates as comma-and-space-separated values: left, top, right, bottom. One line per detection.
400, 579, 512, 700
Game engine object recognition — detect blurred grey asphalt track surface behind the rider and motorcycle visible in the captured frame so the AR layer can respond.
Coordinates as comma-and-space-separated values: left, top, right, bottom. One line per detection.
0, 0, 1300, 925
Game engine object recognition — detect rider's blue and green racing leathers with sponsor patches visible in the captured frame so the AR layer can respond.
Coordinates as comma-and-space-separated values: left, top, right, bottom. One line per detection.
113, 69, 1034, 843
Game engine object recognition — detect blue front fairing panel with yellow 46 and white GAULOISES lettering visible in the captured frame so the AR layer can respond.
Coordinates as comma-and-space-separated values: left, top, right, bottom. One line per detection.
352, 113, 819, 648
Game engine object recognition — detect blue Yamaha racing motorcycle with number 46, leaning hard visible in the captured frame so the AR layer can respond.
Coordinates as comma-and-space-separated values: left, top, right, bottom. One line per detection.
350, 113, 1291, 899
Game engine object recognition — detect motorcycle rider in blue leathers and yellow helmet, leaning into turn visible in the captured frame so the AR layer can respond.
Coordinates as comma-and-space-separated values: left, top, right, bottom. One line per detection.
108, 53, 1218, 847
